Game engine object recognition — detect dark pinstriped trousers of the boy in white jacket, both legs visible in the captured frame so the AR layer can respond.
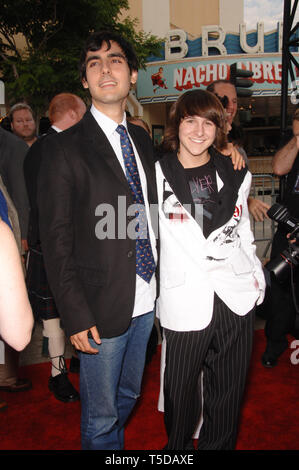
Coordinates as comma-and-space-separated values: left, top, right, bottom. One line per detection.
164, 296, 254, 450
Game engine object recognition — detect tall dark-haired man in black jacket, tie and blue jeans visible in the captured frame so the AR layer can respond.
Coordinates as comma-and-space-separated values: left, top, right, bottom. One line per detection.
38, 32, 157, 450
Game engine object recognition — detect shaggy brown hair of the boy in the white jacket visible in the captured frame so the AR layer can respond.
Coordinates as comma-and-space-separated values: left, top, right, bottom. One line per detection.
163, 90, 227, 152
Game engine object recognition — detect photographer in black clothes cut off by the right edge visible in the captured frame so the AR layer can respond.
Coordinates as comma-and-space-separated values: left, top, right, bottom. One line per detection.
262, 109, 299, 367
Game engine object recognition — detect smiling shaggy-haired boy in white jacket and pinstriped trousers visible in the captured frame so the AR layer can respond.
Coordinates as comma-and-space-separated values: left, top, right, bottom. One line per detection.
156, 90, 265, 450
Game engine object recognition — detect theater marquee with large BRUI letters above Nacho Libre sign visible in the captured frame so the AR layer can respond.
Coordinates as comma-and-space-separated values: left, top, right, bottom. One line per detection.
137, 22, 299, 104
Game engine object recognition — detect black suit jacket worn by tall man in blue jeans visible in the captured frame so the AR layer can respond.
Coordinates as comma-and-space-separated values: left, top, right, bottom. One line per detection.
38, 111, 157, 337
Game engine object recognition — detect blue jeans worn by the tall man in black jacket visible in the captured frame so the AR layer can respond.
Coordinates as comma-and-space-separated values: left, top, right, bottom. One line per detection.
79, 312, 154, 450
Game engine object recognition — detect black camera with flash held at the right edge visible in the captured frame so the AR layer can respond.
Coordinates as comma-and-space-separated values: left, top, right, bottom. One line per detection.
266, 204, 299, 283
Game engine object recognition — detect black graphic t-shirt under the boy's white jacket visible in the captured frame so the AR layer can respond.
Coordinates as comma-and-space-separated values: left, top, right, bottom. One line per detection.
185, 160, 218, 237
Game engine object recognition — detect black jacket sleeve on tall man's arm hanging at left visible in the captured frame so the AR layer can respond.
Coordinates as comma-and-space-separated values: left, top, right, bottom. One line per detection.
37, 136, 95, 336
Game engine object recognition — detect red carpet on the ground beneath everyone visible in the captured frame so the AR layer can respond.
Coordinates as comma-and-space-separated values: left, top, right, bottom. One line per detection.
0, 331, 299, 450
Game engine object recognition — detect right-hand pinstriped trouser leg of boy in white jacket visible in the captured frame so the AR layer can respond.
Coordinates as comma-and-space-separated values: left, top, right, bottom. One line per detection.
198, 302, 254, 450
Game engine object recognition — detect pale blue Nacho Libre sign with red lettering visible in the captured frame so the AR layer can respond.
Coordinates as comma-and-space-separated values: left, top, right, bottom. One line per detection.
137, 53, 298, 104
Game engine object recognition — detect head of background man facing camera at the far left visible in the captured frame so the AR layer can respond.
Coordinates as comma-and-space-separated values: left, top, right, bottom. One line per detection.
9, 103, 37, 147
